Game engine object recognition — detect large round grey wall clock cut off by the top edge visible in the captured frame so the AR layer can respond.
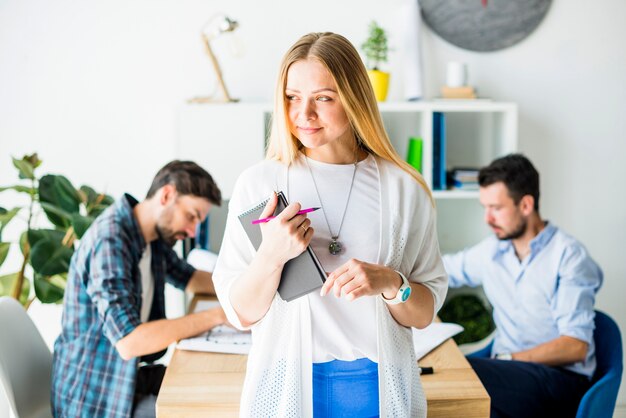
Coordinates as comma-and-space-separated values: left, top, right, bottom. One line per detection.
419, 0, 552, 52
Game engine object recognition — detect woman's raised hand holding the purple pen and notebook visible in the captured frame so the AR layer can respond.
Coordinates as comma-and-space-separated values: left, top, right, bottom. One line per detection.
258, 193, 314, 267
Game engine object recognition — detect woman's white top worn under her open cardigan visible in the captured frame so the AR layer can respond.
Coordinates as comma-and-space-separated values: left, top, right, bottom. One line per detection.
287, 156, 380, 363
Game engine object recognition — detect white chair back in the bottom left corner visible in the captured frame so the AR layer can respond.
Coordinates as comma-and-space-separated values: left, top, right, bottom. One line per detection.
0, 296, 52, 418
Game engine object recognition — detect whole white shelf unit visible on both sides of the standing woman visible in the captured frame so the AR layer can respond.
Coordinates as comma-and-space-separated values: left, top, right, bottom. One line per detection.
176, 100, 518, 252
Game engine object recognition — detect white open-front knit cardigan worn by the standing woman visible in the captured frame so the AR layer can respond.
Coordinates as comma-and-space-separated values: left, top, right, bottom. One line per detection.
213, 158, 447, 418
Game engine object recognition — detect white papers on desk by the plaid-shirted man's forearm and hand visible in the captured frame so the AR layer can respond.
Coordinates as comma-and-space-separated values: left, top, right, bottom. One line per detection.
176, 300, 252, 354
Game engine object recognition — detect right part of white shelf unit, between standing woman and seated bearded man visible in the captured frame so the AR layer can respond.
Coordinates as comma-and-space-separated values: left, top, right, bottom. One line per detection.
372, 100, 518, 253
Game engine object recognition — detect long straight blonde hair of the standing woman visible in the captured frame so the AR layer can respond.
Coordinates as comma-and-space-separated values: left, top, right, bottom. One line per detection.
266, 32, 432, 198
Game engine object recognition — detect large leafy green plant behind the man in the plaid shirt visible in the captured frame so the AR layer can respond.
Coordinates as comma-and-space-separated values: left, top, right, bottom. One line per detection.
0, 154, 113, 307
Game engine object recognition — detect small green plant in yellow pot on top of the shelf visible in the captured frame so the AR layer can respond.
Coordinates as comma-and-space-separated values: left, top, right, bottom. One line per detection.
361, 21, 389, 102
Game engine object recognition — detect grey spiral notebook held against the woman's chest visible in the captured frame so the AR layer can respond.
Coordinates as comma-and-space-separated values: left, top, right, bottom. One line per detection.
239, 192, 326, 302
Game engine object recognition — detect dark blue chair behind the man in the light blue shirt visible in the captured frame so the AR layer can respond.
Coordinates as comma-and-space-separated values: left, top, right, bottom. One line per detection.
576, 311, 624, 418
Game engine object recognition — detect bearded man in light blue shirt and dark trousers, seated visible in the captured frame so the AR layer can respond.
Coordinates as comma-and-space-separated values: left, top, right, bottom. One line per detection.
443, 154, 602, 417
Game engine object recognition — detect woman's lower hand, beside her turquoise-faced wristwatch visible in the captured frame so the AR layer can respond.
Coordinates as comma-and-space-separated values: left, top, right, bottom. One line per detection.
320, 258, 402, 301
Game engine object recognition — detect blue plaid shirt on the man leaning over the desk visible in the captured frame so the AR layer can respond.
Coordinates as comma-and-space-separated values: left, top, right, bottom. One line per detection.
51, 195, 194, 418
